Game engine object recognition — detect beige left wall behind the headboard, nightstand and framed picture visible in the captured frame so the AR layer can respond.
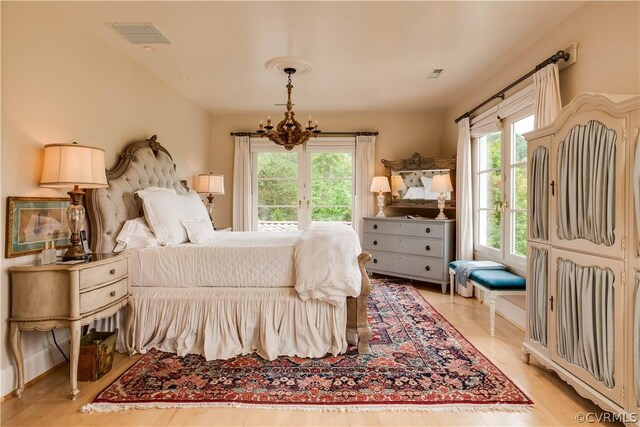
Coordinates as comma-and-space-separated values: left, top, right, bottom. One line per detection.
0, 2, 211, 396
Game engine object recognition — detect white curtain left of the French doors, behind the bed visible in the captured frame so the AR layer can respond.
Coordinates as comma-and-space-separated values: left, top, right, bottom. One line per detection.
233, 136, 252, 231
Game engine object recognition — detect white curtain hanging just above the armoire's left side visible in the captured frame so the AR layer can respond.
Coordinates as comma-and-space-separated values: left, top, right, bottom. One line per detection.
533, 64, 562, 129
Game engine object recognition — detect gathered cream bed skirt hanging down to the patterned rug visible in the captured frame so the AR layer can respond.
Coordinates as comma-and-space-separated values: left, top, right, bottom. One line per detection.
100, 287, 347, 360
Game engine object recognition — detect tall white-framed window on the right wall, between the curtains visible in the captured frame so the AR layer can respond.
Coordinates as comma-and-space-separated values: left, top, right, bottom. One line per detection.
474, 106, 533, 268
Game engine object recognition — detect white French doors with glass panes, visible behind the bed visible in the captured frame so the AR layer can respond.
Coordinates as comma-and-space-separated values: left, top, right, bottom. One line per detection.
251, 138, 355, 231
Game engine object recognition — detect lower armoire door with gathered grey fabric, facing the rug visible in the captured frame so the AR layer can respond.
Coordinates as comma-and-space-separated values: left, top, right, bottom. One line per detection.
549, 249, 626, 402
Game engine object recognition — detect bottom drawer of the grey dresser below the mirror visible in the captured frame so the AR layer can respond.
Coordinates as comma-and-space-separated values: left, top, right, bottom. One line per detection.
367, 251, 443, 281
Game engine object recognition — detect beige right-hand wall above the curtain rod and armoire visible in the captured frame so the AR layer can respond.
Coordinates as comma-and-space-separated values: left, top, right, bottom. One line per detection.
442, 2, 640, 155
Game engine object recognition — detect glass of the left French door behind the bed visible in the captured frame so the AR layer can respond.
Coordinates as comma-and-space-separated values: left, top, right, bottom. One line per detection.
256, 152, 298, 231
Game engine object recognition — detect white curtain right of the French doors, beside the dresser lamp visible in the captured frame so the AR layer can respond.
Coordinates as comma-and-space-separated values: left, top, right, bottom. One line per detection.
353, 135, 376, 239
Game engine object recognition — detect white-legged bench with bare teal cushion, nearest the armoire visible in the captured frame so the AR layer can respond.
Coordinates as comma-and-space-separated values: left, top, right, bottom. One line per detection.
449, 261, 526, 336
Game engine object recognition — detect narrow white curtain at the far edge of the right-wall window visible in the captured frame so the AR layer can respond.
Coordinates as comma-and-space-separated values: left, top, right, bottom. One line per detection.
456, 117, 473, 259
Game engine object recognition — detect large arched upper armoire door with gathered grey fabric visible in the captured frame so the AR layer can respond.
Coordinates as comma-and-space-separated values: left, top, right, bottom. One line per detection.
549, 111, 627, 259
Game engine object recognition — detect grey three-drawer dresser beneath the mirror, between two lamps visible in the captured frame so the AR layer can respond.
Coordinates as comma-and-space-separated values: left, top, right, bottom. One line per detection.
362, 217, 455, 293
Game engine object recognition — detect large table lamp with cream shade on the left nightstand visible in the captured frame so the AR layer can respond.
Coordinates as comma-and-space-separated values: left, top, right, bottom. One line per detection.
40, 142, 108, 261
